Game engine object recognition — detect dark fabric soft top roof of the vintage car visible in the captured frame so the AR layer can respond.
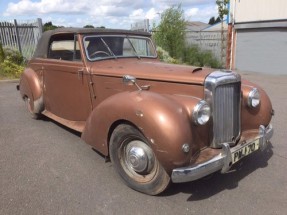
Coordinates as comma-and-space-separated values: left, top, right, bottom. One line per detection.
33, 28, 151, 58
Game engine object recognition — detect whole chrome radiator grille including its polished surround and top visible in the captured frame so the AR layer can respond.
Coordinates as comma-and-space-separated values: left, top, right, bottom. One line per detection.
204, 71, 241, 148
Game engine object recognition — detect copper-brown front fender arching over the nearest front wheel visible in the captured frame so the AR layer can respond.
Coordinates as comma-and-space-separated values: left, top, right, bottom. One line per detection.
82, 91, 204, 172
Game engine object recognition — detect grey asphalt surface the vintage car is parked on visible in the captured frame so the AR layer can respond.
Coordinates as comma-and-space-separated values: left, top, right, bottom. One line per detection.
0, 73, 287, 215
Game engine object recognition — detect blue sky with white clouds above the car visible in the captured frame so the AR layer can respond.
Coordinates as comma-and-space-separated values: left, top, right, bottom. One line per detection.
0, 0, 218, 29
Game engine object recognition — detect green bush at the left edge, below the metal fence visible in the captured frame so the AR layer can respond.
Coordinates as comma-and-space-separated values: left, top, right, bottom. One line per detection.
0, 44, 24, 79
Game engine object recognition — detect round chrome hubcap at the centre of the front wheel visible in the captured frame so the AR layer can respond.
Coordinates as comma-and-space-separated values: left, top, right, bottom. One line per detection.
126, 140, 154, 174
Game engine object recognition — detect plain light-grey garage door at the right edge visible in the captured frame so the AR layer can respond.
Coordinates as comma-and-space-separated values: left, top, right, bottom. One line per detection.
235, 28, 287, 75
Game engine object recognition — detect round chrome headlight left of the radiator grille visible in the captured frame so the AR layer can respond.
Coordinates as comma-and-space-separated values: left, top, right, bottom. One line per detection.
192, 100, 210, 125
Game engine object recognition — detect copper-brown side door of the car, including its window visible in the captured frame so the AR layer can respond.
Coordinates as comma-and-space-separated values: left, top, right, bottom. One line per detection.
43, 34, 92, 121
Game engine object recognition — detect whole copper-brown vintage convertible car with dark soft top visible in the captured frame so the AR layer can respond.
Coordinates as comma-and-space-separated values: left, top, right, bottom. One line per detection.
18, 28, 274, 195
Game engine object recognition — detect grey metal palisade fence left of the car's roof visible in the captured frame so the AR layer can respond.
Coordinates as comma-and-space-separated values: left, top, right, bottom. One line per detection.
0, 19, 43, 59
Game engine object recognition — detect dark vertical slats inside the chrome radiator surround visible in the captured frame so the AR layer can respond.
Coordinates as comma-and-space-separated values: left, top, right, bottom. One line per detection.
212, 83, 240, 144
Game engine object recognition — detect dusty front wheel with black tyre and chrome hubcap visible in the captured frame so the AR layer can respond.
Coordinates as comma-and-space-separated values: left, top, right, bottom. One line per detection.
109, 124, 170, 195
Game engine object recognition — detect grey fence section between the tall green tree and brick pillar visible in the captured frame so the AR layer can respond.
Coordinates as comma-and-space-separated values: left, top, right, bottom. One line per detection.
185, 30, 227, 64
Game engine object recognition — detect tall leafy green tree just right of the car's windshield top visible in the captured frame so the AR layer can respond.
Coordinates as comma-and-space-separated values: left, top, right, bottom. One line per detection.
154, 4, 186, 59
